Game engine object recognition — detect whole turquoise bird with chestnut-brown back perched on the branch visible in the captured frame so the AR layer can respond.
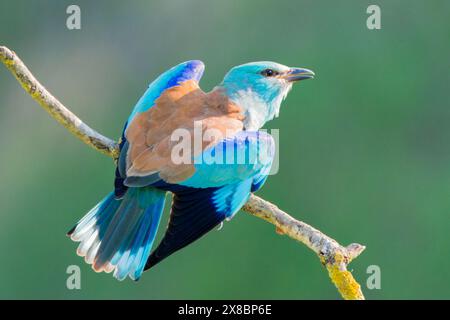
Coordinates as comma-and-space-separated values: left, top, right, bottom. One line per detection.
67, 60, 314, 280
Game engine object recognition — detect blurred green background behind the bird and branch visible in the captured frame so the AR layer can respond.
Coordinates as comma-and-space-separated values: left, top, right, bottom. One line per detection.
0, 0, 450, 299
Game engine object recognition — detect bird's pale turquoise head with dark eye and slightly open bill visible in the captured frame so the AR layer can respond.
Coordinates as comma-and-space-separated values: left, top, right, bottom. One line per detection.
221, 61, 314, 130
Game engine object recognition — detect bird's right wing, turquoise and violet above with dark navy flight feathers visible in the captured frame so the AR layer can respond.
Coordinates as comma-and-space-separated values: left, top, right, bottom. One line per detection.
142, 131, 275, 269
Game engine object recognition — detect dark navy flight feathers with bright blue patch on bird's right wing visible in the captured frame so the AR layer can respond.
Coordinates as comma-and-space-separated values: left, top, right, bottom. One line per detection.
145, 179, 252, 270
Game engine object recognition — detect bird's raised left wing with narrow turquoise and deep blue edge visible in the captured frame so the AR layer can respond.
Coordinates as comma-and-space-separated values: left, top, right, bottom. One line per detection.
115, 60, 205, 197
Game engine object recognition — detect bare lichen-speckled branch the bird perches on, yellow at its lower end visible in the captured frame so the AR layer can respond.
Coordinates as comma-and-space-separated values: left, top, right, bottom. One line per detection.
0, 46, 365, 300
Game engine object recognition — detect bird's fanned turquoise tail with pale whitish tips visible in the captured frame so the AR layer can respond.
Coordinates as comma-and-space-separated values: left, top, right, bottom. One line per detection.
68, 187, 165, 280
